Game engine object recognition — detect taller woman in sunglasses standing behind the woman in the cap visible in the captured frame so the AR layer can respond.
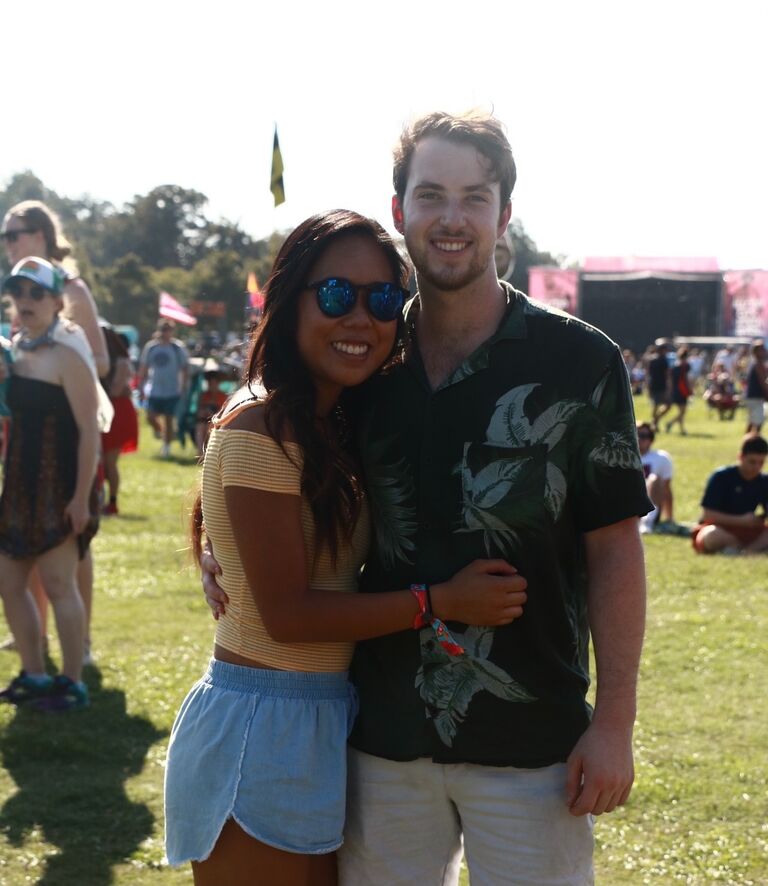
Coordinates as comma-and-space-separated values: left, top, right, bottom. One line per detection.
0, 200, 110, 664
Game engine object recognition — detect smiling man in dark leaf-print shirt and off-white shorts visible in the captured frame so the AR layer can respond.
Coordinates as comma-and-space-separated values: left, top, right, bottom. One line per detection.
339, 114, 651, 886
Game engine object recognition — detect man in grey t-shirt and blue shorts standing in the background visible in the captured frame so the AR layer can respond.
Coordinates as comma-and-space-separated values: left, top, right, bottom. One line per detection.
139, 319, 189, 458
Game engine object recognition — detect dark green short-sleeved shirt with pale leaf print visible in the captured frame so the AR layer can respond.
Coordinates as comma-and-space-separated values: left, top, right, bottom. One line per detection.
350, 287, 651, 767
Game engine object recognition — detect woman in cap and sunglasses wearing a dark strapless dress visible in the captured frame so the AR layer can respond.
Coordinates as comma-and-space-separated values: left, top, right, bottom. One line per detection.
0, 257, 108, 711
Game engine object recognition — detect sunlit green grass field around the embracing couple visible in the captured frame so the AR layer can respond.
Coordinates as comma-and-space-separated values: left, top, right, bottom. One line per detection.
0, 401, 768, 886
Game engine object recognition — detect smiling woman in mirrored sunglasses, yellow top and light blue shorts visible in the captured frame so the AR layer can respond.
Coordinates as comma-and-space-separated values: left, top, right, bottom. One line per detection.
166, 210, 525, 886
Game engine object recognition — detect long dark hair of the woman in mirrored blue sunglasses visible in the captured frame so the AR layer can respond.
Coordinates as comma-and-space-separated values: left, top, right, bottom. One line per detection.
192, 209, 407, 562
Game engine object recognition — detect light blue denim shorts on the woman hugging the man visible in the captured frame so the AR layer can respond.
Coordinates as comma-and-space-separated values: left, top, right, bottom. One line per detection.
165, 659, 357, 865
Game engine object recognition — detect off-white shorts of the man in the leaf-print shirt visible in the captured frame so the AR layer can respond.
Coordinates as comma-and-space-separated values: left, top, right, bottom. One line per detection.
339, 748, 594, 886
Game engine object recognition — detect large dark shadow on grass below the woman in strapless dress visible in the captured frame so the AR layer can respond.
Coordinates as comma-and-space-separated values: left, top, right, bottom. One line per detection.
0, 668, 164, 886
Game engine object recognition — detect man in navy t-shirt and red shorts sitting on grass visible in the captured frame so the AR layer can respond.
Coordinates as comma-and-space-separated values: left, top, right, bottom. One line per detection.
691, 434, 768, 554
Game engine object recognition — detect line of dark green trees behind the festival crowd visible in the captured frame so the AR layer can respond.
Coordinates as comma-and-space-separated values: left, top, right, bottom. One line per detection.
0, 171, 556, 339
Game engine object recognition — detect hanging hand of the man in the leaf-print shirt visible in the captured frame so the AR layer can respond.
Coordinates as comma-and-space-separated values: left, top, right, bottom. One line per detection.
566, 721, 635, 815
